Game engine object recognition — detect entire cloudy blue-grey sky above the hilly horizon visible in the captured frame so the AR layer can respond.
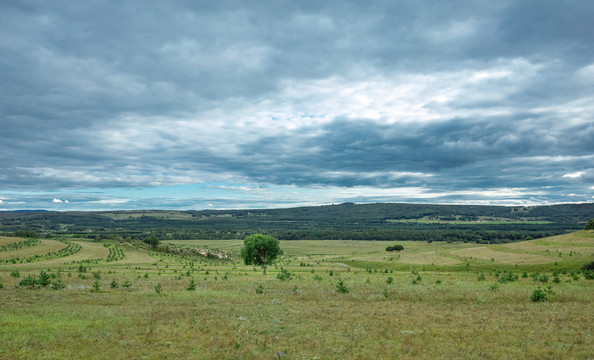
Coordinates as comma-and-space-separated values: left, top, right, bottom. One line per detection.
0, 0, 594, 211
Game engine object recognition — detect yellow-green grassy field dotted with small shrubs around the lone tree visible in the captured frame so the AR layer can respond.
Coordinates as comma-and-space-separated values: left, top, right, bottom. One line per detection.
0, 231, 594, 359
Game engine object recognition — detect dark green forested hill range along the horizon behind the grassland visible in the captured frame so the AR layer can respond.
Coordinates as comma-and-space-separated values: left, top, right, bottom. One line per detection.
0, 203, 594, 242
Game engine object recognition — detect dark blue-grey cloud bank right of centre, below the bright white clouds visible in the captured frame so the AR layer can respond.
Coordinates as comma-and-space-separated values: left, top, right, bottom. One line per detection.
238, 118, 594, 187
